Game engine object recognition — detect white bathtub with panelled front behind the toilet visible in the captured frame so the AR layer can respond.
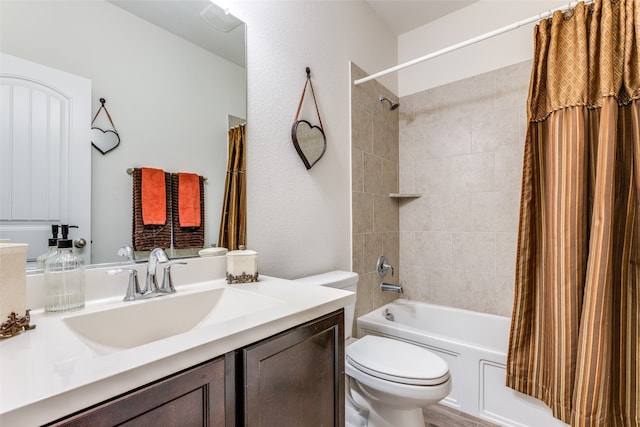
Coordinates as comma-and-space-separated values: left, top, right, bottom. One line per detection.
357, 299, 567, 427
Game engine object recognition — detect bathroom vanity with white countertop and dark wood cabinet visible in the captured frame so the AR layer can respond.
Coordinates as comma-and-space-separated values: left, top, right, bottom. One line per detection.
0, 259, 355, 426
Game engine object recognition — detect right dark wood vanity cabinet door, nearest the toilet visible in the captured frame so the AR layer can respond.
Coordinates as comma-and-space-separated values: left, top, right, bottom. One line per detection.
238, 310, 345, 427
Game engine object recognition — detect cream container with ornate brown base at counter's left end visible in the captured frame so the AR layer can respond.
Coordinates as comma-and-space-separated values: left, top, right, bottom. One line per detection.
0, 243, 29, 323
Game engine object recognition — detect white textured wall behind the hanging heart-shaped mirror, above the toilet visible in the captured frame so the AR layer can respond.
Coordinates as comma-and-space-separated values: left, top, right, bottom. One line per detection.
232, 1, 396, 278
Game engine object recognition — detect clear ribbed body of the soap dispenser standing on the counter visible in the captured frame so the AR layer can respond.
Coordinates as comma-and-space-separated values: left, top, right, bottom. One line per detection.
44, 239, 85, 313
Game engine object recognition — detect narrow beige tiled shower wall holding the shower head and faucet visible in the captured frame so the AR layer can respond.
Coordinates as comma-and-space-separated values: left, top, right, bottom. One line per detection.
351, 64, 400, 324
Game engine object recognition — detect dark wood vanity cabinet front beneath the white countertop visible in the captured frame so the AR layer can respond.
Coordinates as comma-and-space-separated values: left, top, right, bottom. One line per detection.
47, 310, 345, 427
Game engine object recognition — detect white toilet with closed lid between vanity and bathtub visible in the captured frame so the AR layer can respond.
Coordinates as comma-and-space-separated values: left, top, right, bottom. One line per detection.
297, 271, 451, 427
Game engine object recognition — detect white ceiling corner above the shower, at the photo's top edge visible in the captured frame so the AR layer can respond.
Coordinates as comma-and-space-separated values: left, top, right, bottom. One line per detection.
367, 0, 478, 36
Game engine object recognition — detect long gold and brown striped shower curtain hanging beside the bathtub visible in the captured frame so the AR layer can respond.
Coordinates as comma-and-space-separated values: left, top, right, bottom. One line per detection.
507, 0, 640, 427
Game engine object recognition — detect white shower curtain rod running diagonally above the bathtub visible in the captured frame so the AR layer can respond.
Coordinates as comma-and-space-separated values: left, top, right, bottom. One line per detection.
353, 0, 595, 86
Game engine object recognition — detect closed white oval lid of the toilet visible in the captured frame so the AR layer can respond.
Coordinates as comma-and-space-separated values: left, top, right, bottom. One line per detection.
346, 335, 449, 385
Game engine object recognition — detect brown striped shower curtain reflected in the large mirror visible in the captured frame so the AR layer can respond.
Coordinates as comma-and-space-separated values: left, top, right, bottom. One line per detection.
218, 125, 247, 251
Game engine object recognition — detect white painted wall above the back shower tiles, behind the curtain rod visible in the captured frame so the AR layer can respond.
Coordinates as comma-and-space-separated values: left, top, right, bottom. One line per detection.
398, 0, 568, 97
